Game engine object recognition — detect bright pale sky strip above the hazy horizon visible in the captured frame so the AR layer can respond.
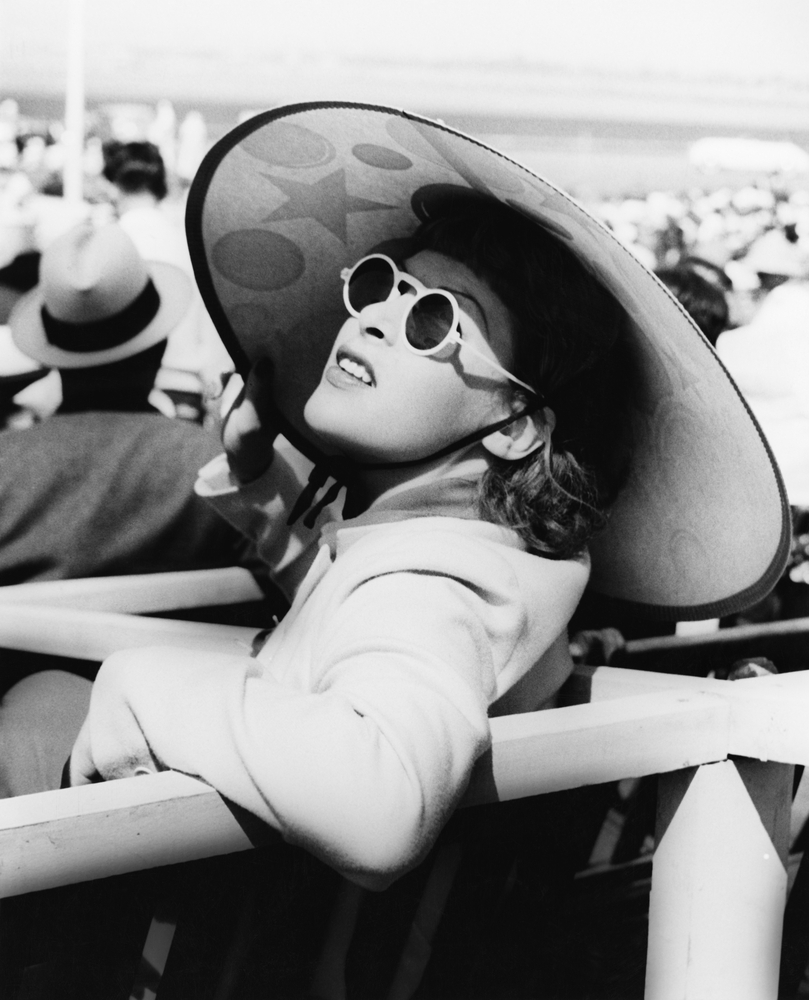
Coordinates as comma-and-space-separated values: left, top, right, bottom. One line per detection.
0, 0, 809, 82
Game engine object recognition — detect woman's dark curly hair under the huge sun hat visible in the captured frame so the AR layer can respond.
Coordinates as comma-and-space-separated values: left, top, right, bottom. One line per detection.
413, 200, 633, 559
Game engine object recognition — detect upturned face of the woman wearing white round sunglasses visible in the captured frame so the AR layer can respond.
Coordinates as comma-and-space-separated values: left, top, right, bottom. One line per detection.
304, 250, 513, 462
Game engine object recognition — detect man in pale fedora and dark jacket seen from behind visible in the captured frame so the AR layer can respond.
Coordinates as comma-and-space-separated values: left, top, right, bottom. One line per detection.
0, 215, 262, 585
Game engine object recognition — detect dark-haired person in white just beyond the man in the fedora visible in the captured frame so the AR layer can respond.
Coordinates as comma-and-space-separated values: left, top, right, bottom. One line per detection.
103, 141, 233, 423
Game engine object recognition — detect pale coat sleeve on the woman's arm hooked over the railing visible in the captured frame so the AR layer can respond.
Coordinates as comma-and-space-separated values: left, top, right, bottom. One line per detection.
80, 573, 494, 888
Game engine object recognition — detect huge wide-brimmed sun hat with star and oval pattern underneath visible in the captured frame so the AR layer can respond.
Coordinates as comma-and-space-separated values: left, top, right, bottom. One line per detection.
186, 102, 790, 620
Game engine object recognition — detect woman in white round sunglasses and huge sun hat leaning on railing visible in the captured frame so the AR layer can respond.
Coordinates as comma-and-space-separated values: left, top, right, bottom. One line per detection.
0, 102, 788, 996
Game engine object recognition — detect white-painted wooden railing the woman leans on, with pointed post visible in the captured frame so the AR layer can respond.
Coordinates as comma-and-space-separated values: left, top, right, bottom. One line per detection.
0, 571, 809, 1000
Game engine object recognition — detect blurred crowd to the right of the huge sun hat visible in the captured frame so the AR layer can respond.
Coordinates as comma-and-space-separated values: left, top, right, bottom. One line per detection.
590, 174, 809, 624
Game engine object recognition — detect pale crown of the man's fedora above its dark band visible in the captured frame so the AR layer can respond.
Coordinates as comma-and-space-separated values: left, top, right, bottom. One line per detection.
40, 223, 149, 324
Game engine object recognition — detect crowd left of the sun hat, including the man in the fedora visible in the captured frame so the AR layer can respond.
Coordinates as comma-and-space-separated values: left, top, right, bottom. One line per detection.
0, 101, 274, 608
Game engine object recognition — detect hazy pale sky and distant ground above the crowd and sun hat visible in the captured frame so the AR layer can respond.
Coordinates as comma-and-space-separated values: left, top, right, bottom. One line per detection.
0, 0, 809, 196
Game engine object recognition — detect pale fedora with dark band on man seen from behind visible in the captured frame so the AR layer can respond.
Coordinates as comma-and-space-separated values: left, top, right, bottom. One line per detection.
9, 222, 193, 368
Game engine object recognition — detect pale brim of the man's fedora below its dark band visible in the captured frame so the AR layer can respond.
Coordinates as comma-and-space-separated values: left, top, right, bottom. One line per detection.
8, 261, 194, 368
